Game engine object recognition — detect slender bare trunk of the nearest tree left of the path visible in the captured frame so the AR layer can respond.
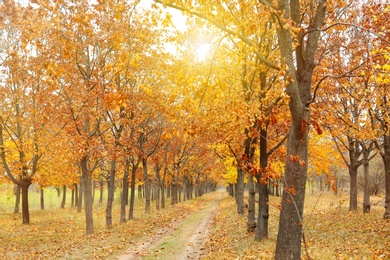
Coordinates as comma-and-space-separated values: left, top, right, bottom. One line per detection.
80, 157, 94, 235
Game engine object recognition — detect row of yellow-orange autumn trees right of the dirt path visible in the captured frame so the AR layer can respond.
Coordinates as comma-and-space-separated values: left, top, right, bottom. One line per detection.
155, 1, 390, 259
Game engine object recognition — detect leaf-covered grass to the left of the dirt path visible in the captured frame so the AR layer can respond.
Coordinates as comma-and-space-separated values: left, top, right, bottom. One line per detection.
0, 184, 207, 259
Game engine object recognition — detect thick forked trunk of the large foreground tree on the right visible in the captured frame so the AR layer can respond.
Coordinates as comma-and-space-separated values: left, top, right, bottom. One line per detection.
275, 0, 326, 260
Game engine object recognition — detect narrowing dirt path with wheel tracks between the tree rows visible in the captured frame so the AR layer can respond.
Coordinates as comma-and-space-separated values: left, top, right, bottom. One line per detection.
119, 191, 224, 260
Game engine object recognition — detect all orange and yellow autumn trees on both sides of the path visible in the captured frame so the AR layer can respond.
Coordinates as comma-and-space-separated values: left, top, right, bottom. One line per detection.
0, 0, 390, 259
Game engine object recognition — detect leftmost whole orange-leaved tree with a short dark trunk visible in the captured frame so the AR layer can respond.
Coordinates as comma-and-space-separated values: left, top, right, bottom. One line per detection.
0, 1, 61, 224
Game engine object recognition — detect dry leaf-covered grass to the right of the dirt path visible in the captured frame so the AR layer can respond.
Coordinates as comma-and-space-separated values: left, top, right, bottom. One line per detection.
207, 192, 390, 259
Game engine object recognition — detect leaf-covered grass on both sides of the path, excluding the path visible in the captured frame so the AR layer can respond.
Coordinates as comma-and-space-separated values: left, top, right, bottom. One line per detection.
0, 186, 390, 259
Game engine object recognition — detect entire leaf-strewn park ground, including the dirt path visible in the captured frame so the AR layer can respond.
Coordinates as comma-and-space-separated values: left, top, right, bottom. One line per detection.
0, 186, 390, 260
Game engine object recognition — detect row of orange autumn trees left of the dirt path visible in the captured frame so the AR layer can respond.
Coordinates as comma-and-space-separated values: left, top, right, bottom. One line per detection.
0, 1, 222, 234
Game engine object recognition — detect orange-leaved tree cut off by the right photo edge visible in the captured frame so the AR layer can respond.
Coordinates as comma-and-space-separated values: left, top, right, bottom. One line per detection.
361, 1, 390, 218
